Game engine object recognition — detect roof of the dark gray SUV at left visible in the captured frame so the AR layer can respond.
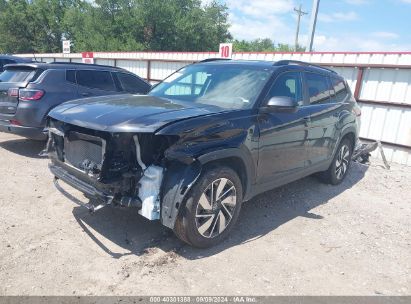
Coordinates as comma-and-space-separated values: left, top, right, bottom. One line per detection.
5, 62, 128, 72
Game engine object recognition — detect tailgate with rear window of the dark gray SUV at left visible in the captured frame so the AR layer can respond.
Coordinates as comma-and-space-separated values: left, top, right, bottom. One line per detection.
0, 66, 37, 119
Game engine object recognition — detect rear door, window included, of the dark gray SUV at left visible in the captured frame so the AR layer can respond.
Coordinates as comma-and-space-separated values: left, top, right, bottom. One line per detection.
76, 70, 119, 98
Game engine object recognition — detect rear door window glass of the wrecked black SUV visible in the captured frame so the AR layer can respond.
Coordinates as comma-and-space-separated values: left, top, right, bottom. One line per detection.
305, 73, 331, 104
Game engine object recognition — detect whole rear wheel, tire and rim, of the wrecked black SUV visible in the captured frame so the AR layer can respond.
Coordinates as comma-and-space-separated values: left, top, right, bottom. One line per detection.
320, 138, 353, 185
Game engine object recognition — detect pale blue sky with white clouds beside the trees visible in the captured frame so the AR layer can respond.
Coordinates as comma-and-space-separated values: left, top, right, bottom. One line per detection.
212, 0, 411, 51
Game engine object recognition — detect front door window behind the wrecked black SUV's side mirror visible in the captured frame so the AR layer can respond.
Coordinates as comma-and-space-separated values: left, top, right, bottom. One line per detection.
267, 72, 303, 106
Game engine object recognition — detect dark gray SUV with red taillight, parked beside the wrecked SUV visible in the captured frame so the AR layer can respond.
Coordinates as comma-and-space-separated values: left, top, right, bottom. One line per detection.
0, 62, 151, 140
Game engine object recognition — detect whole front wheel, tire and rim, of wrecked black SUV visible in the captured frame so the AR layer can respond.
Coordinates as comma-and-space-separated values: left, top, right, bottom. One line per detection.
174, 167, 243, 248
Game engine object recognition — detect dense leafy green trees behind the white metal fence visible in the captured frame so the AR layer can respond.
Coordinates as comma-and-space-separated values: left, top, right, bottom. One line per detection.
0, 0, 302, 53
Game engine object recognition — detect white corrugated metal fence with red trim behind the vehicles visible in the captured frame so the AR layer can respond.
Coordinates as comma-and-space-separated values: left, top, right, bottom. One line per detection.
18, 52, 411, 165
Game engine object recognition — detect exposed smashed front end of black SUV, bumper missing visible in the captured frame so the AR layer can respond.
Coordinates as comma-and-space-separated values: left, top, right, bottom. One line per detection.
43, 121, 201, 228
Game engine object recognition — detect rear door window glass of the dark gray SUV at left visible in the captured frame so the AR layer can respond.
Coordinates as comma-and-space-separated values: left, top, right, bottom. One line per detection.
76, 70, 116, 91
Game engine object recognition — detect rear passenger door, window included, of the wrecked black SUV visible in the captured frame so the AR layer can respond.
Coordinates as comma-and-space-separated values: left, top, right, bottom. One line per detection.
304, 72, 341, 166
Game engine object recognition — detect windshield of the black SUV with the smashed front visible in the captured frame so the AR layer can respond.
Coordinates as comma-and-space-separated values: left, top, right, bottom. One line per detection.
149, 65, 271, 109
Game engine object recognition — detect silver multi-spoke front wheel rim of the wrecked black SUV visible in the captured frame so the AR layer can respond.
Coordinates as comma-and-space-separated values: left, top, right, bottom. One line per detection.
195, 178, 237, 238
